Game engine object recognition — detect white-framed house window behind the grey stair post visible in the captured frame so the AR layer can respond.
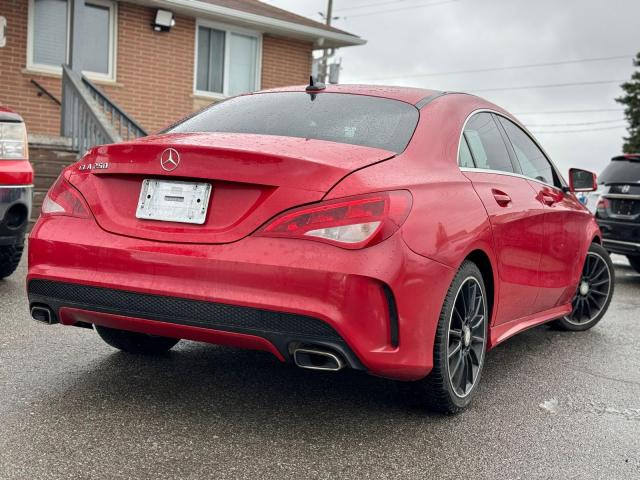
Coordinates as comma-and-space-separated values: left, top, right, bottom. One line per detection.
27, 0, 116, 80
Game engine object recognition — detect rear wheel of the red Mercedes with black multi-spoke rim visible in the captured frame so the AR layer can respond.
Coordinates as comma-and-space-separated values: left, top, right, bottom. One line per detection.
410, 261, 488, 414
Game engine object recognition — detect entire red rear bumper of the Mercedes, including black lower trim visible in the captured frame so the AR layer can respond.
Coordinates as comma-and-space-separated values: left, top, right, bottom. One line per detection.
28, 217, 455, 380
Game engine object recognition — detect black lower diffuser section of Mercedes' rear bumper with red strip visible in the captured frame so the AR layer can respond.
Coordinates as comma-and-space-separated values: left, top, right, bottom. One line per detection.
27, 279, 364, 370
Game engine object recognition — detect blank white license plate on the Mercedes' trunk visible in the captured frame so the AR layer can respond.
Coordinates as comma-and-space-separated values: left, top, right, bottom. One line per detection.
136, 179, 211, 225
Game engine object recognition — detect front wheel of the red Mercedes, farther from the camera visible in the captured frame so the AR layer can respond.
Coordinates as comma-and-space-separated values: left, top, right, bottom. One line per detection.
553, 243, 615, 332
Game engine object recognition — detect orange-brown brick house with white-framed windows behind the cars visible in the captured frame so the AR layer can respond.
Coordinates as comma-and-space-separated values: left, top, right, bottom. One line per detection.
0, 0, 364, 135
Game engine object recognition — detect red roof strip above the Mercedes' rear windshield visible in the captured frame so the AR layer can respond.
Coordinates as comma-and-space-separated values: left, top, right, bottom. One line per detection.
257, 84, 443, 105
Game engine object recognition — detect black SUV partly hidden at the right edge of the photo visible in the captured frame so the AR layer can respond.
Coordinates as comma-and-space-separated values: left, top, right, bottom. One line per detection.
590, 154, 640, 272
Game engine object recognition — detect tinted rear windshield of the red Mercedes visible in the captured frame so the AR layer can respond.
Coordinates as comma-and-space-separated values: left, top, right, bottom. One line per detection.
168, 92, 418, 153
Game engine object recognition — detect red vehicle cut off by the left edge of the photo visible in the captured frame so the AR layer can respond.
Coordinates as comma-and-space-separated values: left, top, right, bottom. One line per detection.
0, 106, 33, 279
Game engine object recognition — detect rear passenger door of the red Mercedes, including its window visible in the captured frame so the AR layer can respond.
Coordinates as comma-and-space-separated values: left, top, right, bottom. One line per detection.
459, 112, 544, 324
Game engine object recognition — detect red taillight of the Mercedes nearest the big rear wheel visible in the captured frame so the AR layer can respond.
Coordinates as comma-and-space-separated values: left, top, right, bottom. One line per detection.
258, 190, 412, 249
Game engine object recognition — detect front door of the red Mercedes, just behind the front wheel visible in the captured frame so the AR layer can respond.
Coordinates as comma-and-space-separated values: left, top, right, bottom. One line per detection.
499, 117, 589, 311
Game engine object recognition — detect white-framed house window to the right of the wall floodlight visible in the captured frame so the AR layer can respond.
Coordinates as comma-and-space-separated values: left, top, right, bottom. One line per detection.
195, 22, 261, 96
